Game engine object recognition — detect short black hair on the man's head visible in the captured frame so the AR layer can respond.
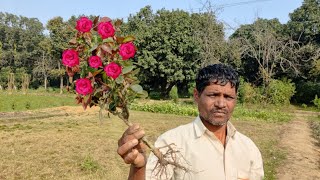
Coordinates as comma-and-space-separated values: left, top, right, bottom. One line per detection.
196, 64, 239, 94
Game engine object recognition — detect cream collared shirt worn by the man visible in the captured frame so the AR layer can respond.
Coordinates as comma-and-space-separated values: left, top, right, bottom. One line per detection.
146, 117, 264, 180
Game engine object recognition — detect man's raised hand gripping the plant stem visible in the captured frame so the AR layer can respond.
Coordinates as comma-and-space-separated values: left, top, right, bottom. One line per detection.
117, 124, 147, 168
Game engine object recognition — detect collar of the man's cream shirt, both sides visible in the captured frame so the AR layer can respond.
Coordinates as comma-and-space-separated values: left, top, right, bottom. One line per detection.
193, 116, 237, 138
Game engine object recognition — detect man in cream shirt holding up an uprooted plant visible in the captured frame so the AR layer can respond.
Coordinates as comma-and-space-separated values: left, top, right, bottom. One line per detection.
118, 64, 264, 180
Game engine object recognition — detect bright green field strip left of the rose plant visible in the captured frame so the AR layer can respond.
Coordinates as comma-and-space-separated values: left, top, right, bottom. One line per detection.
0, 92, 76, 112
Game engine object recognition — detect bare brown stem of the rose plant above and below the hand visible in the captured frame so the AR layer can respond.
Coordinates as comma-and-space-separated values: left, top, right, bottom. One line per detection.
118, 106, 191, 172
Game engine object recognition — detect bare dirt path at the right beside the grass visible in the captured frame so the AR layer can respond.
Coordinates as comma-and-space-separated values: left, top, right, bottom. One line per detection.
277, 111, 320, 180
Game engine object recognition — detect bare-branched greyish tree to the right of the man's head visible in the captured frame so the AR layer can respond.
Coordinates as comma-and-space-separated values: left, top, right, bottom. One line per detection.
231, 19, 300, 87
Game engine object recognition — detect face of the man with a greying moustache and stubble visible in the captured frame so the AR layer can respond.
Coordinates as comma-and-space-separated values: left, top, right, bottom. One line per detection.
194, 82, 237, 126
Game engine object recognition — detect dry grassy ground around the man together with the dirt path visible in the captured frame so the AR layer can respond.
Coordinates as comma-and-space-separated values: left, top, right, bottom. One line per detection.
0, 106, 320, 180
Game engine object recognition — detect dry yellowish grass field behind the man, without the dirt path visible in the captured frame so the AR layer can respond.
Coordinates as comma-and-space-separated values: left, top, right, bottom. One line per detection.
0, 107, 284, 180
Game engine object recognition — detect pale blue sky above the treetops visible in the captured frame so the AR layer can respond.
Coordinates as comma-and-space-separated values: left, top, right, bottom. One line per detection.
0, 0, 303, 36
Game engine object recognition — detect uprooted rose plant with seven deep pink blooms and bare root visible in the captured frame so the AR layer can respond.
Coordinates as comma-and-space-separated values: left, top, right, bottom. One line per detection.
62, 17, 186, 176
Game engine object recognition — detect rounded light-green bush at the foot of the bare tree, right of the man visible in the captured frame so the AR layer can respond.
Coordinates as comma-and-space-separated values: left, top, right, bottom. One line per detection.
266, 79, 295, 105
